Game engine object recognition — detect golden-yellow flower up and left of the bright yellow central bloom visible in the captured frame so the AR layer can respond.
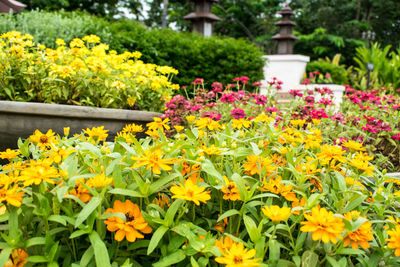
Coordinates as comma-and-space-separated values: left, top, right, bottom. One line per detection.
132, 148, 176, 174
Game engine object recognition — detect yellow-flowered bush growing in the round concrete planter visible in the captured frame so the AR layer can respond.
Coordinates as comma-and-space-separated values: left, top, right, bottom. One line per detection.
0, 31, 179, 111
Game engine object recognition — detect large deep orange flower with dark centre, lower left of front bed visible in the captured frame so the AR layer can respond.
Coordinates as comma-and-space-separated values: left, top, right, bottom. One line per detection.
104, 200, 152, 242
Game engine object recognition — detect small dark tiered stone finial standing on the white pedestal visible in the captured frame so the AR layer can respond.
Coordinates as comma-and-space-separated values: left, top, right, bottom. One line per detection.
272, 5, 298, 54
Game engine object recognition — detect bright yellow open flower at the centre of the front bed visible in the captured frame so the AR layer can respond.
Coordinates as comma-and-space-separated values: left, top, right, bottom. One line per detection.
170, 179, 211, 206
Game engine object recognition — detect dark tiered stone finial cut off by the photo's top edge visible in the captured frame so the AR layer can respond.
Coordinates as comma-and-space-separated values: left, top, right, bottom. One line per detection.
183, 0, 221, 37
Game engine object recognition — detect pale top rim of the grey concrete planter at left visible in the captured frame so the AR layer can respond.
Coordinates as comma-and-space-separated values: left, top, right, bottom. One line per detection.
0, 100, 162, 121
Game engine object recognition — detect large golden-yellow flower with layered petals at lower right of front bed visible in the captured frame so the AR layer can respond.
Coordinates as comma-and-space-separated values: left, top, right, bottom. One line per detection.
300, 206, 344, 244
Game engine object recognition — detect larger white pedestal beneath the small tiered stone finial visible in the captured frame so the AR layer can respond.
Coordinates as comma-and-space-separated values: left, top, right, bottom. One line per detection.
261, 55, 310, 93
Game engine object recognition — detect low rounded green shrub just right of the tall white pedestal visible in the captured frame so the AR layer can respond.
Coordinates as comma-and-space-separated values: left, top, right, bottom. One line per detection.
307, 54, 349, 84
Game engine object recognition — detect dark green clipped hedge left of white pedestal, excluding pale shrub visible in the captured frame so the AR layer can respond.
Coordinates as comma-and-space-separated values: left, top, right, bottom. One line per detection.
106, 21, 264, 85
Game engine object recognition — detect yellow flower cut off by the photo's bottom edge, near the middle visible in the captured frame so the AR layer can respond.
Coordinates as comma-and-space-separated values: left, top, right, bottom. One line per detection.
215, 243, 260, 267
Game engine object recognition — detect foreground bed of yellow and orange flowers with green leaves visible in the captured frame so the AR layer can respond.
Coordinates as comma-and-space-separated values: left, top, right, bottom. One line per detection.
0, 97, 400, 267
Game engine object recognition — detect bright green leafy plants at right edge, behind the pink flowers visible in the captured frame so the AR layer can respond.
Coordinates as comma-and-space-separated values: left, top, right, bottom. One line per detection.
353, 43, 400, 91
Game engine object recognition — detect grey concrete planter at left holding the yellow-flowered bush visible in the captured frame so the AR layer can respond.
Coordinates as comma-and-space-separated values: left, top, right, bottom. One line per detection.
0, 101, 161, 151
